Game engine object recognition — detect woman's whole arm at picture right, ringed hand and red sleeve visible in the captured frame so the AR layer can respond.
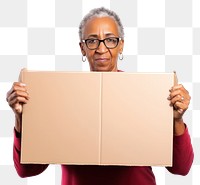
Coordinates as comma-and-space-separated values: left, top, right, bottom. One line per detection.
167, 85, 194, 175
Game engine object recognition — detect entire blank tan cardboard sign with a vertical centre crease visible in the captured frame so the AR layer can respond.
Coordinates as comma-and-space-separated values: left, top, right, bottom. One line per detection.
20, 70, 174, 166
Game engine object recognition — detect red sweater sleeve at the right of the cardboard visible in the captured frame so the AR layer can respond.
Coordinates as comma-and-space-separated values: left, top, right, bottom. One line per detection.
167, 127, 194, 175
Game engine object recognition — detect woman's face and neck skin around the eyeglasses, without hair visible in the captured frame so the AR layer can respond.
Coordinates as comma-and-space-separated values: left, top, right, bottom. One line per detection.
80, 17, 124, 71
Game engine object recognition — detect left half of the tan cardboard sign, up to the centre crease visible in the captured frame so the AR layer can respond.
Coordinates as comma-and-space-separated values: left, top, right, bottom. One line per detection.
21, 71, 101, 164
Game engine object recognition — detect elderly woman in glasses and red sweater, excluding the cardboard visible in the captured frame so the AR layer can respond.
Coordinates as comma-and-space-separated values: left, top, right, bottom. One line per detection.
7, 8, 193, 185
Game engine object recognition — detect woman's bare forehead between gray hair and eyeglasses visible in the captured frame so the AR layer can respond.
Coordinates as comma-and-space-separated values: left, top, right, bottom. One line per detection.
83, 17, 119, 37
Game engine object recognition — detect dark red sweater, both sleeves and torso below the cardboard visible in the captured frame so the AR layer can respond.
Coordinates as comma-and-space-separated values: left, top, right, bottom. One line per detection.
13, 128, 194, 185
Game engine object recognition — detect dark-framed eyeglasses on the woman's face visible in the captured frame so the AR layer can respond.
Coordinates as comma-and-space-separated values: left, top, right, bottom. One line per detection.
82, 37, 121, 50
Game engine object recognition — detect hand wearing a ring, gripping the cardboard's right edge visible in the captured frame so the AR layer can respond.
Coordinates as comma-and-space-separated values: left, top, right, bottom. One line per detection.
168, 84, 191, 121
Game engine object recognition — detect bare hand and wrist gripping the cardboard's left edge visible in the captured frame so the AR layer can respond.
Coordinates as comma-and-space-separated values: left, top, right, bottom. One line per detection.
6, 82, 29, 133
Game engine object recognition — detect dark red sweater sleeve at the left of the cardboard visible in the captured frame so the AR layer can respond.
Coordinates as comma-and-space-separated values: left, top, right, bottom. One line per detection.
13, 130, 48, 178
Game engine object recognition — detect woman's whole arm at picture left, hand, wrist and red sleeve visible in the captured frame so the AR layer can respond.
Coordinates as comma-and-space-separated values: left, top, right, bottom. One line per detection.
6, 82, 48, 177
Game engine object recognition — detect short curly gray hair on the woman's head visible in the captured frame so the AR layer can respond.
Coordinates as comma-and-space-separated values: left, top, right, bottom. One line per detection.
79, 7, 124, 40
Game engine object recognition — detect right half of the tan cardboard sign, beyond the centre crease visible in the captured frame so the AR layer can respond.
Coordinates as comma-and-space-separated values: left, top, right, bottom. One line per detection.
101, 73, 173, 166
